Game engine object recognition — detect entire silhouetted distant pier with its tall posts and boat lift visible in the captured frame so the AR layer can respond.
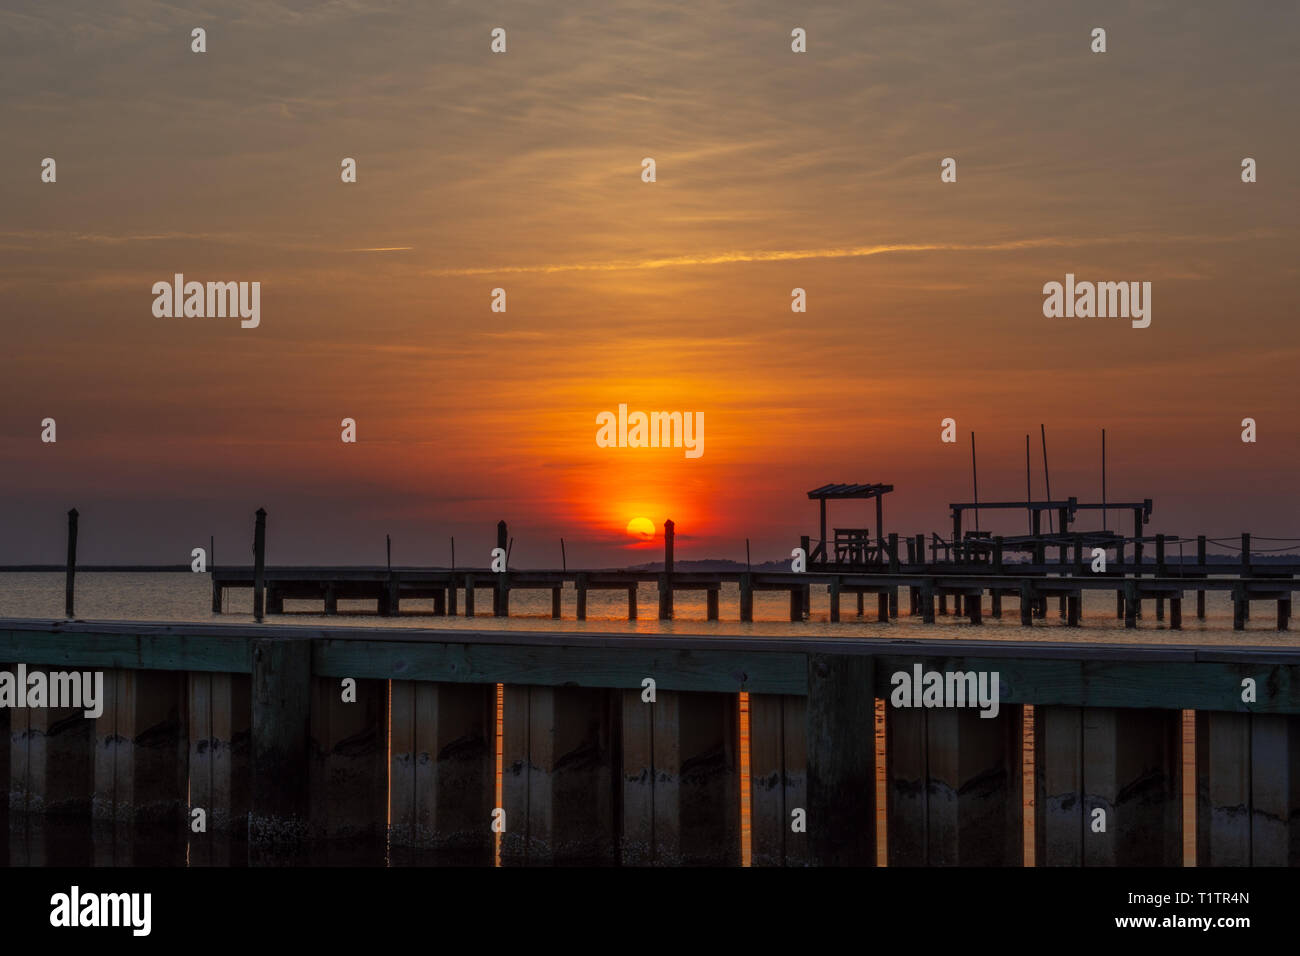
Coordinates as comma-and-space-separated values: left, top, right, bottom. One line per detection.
210, 512, 1300, 631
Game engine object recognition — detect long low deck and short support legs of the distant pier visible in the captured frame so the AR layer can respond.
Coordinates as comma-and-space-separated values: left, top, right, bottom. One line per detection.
212, 563, 1300, 630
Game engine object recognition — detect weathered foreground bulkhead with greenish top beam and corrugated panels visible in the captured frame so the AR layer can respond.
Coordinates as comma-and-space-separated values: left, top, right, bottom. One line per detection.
0, 620, 1300, 866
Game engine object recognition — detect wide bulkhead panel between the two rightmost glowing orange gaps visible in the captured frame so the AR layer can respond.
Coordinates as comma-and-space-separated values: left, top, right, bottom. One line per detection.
1034, 706, 1183, 866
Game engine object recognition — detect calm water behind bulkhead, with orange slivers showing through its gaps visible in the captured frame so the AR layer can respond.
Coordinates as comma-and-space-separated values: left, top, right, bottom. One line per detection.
0, 572, 1300, 865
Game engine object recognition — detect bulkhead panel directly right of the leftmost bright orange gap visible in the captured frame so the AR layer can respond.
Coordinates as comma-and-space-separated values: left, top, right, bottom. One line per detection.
501, 684, 621, 865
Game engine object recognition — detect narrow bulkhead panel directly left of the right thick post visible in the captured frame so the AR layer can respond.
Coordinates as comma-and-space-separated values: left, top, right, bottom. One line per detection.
749, 693, 809, 866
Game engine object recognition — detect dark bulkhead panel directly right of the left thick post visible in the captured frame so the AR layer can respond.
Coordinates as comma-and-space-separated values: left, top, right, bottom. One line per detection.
309, 676, 389, 839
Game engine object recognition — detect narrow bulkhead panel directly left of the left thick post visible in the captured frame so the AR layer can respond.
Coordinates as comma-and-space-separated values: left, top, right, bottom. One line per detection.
187, 672, 252, 835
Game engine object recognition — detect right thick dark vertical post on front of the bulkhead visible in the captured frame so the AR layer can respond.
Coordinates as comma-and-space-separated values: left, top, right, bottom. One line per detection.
805, 654, 876, 866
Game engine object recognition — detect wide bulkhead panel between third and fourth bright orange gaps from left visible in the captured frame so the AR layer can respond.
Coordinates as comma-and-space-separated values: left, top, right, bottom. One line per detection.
885, 702, 1024, 866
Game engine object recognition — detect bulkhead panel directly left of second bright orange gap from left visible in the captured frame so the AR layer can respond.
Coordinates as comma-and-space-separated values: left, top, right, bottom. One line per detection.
623, 688, 741, 866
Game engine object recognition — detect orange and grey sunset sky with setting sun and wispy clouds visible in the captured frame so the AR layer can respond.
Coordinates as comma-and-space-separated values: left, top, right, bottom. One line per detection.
0, 0, 1300, 567
